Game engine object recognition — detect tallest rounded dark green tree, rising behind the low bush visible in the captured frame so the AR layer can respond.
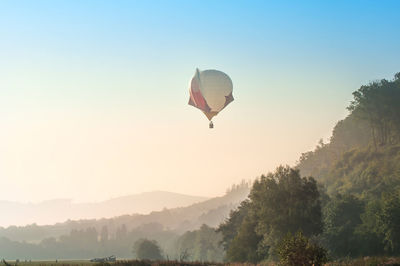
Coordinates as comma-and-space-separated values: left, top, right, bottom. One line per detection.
249, 166, 322, 255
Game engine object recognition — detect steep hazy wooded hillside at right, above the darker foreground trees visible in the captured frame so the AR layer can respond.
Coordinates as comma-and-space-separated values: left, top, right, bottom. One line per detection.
297, 73, 400, 198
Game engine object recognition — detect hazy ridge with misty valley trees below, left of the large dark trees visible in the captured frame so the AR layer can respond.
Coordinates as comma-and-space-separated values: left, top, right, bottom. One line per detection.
0, 184, 250, 262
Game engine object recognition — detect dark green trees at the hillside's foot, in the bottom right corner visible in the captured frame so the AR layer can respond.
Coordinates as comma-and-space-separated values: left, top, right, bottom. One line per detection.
323, 187, 400, 258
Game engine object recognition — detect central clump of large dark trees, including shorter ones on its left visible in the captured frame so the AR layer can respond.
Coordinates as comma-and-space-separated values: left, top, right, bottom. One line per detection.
219, 166, 322, 262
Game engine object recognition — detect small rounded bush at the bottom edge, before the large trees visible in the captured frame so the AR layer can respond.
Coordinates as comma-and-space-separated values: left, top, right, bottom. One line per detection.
277, 231, 328, 266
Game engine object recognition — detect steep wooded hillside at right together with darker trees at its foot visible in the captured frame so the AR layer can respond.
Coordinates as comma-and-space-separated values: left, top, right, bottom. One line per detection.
297, 73, 400, 257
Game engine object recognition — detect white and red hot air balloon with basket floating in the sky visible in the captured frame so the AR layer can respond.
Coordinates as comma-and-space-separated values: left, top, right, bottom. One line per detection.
189, 69, 233, 128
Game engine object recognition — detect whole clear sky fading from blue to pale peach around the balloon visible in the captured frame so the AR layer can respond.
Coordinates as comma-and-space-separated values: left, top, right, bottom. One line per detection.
0, 0, 400, 202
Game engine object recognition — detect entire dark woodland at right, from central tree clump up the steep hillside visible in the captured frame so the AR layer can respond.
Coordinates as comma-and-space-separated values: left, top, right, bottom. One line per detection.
218, 73, 400, 265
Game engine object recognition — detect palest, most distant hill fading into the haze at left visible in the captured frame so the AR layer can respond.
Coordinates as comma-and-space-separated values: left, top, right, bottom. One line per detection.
0, 191, 207, 225
